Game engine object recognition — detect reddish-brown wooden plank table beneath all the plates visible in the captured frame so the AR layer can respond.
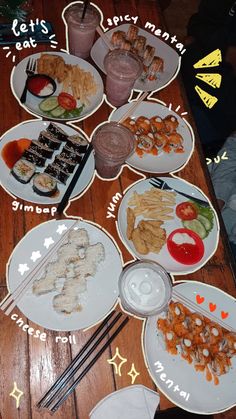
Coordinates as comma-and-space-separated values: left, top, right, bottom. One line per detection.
0, 0, 236, 419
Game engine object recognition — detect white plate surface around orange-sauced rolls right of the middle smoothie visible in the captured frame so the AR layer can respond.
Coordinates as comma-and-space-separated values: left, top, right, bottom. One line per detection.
110, 102, 194, 173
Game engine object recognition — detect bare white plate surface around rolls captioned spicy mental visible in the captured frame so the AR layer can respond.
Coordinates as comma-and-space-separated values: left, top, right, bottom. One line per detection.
90, 23, 181, 92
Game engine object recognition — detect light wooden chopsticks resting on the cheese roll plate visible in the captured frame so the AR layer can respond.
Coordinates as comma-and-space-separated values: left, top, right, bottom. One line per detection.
0, 221, 78, 316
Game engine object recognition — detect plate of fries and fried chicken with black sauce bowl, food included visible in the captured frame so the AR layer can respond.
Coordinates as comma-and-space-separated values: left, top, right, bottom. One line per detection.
11, 52, 104, 121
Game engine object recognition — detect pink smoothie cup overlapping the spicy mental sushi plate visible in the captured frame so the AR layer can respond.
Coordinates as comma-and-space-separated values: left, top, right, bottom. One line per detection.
104, 49, 143, 107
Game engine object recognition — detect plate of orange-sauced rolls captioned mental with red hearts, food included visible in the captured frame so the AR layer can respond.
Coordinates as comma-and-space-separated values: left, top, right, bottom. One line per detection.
143, 281, 236, 414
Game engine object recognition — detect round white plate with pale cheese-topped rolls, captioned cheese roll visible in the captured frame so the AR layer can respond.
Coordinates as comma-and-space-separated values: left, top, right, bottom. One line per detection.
8, 219, 122, 331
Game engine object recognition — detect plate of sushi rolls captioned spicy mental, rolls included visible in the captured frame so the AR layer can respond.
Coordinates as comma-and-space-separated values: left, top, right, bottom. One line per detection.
91, 24, 180, 91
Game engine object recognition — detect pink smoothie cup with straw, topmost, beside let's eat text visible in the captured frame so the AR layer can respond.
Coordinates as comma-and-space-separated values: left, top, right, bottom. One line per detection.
64, 3, 101, 58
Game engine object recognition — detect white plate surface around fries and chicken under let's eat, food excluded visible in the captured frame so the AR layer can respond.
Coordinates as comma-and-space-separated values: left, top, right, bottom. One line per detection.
11, 51, 103, 122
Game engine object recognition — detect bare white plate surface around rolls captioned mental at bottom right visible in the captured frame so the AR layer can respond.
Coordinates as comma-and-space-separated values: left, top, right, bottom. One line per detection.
143, 281, 236, 414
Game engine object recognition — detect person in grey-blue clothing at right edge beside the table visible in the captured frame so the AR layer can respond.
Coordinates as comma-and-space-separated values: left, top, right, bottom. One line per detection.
208, 131, 236, 261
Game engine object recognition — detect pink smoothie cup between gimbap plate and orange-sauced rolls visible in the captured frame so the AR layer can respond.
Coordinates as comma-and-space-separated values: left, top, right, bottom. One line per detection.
92, 122, 135, 179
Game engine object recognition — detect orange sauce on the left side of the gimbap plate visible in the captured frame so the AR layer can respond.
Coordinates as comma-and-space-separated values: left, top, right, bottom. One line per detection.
1, 138, 31, 169
